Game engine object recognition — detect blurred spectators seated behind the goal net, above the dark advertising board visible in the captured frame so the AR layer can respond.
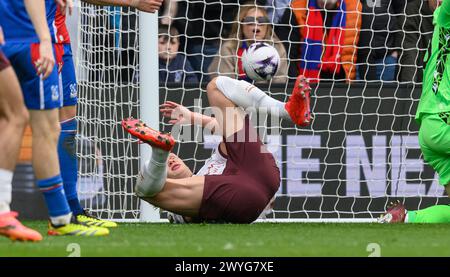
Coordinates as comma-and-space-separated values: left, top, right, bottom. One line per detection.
154, 0, 436, 83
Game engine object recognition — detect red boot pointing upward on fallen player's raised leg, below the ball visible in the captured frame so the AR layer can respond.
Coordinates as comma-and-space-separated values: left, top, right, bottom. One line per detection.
284, 75, 312, 126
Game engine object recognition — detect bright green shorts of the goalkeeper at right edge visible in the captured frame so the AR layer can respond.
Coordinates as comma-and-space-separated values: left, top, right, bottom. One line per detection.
419, 114, 450, 186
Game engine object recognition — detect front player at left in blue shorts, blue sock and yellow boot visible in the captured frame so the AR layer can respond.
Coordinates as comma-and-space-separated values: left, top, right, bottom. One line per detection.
0, 0, 109, 236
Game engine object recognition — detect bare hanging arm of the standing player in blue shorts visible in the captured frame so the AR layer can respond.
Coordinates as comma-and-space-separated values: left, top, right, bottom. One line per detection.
24, 0, 55, 79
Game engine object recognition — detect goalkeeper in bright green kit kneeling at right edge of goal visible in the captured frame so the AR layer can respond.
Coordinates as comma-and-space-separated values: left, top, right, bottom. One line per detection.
379, 0, 450, 223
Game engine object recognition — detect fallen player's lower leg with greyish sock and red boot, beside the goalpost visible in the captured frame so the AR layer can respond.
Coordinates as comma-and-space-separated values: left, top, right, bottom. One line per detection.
122, 118, 175, 197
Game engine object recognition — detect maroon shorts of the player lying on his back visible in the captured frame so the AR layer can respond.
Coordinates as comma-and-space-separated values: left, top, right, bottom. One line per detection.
199, 116, 280, 223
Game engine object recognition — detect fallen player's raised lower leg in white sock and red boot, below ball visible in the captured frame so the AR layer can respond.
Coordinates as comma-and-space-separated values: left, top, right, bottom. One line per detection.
208, 75, 312, 126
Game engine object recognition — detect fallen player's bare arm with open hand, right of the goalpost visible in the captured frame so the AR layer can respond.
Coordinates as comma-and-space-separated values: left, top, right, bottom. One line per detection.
160, 101, 219, 132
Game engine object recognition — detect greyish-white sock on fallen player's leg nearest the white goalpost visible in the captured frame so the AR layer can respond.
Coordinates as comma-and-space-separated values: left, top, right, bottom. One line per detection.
136, 147, 169, 197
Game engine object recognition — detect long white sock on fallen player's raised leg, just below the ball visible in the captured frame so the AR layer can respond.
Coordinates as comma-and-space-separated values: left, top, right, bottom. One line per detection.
216, 76, 291, 119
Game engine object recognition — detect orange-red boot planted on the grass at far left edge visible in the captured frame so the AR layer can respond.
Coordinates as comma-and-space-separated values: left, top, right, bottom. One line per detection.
0, 212, 42, 241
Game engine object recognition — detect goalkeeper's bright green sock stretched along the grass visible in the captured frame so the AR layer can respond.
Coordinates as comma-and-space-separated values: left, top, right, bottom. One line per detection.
405, 205, 450, 223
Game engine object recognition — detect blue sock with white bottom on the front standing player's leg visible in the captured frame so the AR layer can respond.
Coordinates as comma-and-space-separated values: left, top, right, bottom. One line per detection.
37, 175, 71, 225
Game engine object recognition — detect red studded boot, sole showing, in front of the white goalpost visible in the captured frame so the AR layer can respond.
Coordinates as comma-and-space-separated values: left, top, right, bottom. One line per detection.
122, 117, 175, 152
